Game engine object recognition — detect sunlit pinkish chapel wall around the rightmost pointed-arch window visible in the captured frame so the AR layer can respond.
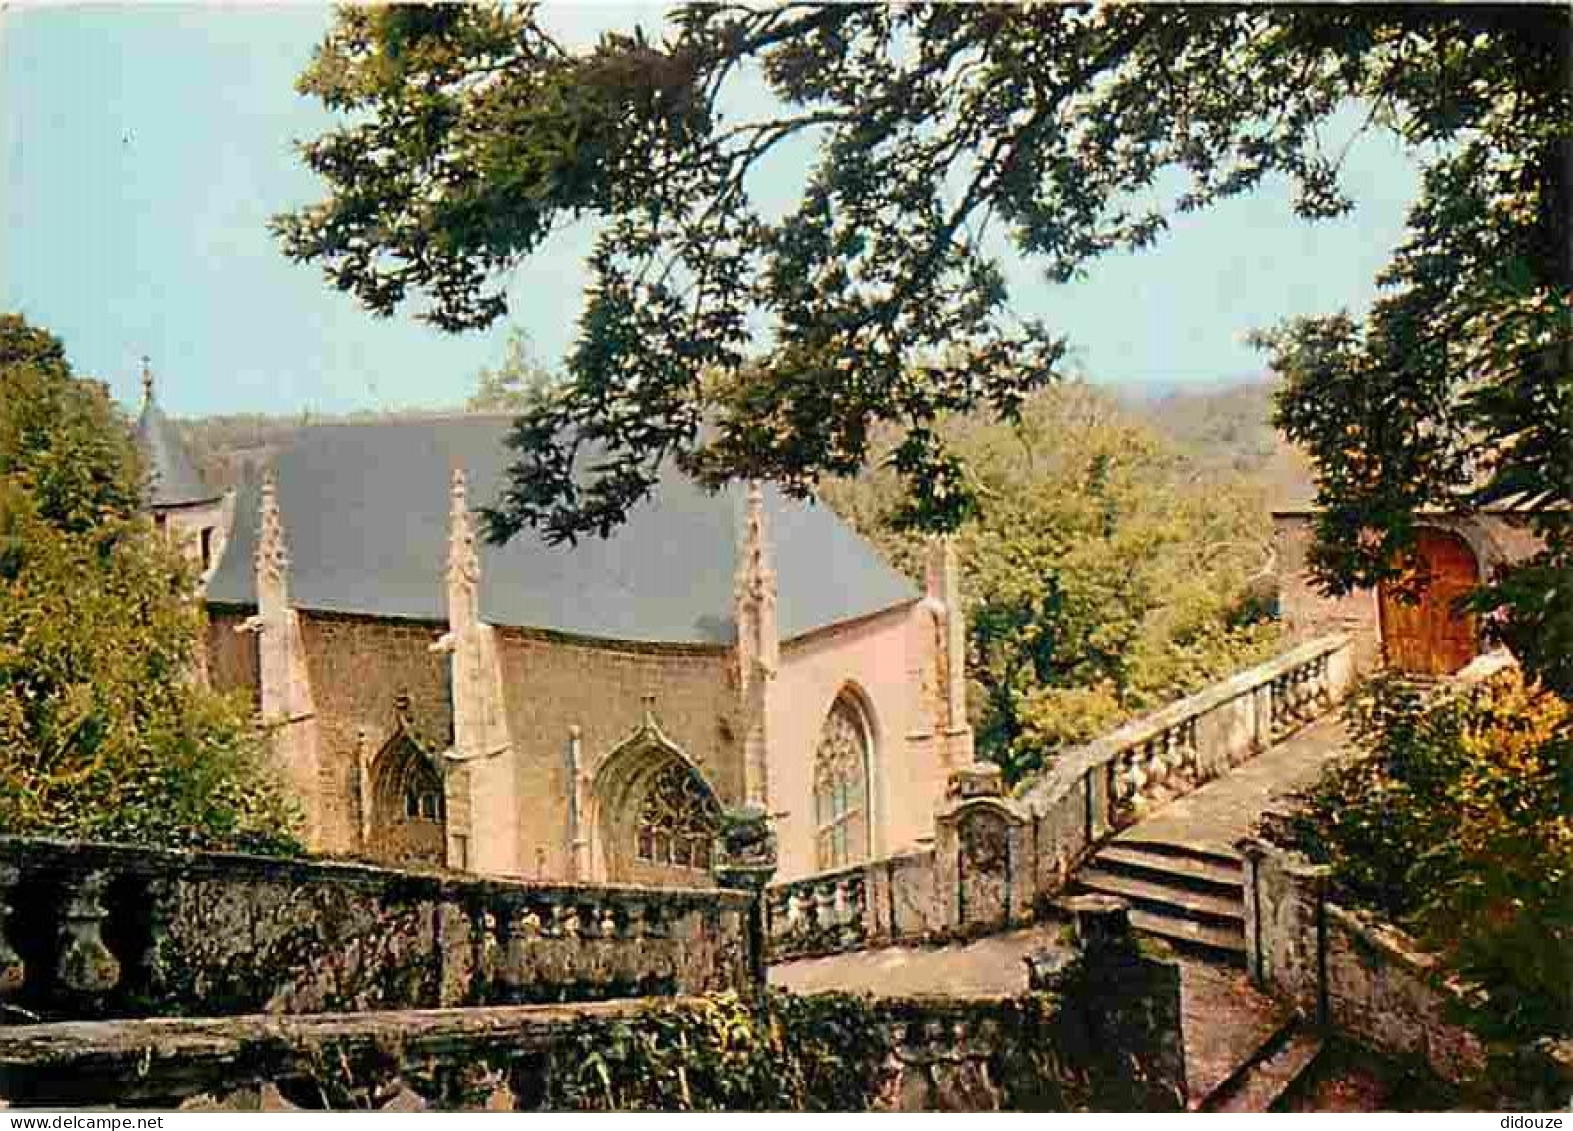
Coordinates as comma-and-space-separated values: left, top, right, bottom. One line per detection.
769, 602, 947, 881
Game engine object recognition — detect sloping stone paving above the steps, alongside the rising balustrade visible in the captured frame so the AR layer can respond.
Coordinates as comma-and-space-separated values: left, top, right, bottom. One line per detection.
1115, 711, 1348, 853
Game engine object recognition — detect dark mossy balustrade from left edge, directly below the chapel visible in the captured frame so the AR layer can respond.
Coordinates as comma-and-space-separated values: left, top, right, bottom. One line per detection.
0, 837, 752, 1021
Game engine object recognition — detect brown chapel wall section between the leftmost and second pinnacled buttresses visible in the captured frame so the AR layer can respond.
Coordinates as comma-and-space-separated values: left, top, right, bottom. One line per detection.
299, 610, 453, 854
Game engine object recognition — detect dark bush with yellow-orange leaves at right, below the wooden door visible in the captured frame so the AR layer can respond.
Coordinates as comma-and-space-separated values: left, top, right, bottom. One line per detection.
1269, 672, 1573, 1037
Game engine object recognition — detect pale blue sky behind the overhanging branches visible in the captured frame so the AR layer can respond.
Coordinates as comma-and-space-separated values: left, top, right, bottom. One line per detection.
0, 5, 1416, 415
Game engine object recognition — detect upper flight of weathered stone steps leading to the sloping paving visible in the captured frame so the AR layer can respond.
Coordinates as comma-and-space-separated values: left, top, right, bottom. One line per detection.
1076, 837, 1246, 966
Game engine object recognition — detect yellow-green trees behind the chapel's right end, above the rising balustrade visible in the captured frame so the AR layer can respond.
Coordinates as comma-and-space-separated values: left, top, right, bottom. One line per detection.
824, 384, 1280, 780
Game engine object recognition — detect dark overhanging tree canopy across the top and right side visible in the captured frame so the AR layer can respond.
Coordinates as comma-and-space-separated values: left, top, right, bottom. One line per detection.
275, 3, 1573, 688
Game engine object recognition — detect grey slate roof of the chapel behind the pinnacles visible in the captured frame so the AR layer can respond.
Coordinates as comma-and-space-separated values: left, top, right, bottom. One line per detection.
208, 415, 919, 645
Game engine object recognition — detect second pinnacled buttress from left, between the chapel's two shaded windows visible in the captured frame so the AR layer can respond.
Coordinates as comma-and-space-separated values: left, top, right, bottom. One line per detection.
444, 467, 525, 876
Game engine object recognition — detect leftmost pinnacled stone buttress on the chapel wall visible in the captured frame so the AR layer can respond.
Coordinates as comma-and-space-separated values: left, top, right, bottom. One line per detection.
250, 472, 326, 849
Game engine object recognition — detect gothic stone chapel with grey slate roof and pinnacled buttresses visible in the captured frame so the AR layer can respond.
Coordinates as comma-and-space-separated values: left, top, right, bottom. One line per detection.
138, 381, 972, 886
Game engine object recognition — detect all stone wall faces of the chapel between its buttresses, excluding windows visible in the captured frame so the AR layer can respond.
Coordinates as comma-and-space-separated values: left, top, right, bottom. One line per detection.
208, 604, 945, 881
